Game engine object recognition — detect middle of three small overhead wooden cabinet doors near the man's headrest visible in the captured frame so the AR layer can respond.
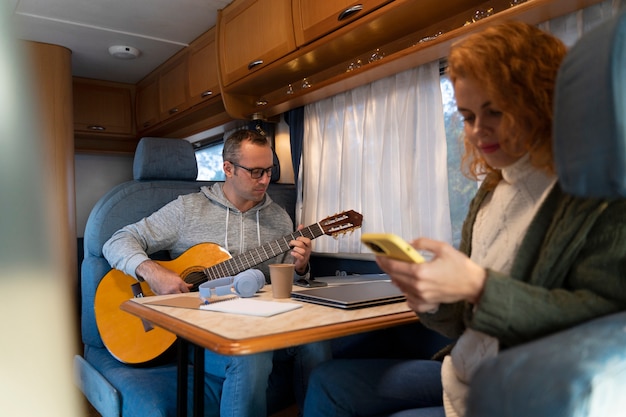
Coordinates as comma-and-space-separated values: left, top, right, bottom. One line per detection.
159, 53, 189, 120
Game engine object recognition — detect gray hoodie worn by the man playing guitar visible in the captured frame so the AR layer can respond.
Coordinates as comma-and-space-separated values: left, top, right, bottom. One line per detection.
102, 183, 294, 280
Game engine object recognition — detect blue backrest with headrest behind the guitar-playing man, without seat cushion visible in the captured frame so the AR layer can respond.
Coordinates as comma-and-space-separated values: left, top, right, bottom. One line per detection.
81, 138, 296, 347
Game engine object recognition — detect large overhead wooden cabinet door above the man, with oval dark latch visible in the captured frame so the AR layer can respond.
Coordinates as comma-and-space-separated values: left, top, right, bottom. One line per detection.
217, 0, 296, 85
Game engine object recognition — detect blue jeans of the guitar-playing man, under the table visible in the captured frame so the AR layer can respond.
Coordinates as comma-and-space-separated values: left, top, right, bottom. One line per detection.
204, 342, 331, 417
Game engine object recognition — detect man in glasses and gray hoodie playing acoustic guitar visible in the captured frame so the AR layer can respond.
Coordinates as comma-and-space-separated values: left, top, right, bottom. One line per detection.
103, 130, 330, 417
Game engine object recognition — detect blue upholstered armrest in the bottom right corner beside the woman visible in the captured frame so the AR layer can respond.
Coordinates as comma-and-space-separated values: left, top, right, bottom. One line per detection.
467, 312, 626, 417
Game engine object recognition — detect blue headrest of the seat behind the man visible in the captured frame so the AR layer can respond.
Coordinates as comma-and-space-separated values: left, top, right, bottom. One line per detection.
133, 137, 198, 181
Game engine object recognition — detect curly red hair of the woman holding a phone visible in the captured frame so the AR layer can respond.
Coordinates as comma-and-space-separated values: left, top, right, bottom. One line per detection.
447, 22, 567, 186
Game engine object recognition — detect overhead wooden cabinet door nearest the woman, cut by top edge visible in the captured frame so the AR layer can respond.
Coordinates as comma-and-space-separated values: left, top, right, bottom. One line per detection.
293, 0, 391, 46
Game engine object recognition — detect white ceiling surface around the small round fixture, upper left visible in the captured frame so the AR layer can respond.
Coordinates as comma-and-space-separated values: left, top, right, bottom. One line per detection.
11, 0, 230, 83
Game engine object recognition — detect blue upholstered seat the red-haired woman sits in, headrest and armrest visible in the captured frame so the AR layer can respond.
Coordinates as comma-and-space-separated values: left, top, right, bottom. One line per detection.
467, 12, 626, 417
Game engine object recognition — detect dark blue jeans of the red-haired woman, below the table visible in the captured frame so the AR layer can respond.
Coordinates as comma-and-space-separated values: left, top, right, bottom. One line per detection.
304, 359, 445, 417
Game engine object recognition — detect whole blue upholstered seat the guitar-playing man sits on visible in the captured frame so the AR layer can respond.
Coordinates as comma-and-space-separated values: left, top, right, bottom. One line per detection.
75, 138, 296, 417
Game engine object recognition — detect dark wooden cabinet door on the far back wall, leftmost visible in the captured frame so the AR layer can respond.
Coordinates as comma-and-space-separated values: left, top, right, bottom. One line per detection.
73, 79, 133, 135
